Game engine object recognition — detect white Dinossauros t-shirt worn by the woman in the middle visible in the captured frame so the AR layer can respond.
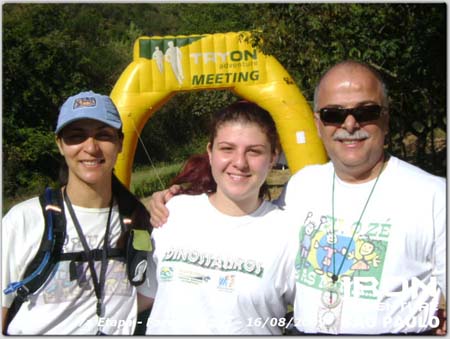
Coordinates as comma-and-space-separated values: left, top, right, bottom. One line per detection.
140, 194, 297, 335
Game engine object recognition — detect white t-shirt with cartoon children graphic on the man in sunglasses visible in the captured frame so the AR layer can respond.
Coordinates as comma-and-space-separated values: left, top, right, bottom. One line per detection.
280, 157, 446, 334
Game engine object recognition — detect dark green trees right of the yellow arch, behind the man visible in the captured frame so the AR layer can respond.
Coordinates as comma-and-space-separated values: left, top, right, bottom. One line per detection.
246, 3, 447, 175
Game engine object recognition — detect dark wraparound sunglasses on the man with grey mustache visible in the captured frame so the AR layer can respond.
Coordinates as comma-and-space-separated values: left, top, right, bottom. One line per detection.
319, 105, 384, 124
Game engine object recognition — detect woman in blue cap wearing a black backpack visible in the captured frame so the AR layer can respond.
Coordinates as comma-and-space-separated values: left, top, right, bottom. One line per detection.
2, 92, 151, 335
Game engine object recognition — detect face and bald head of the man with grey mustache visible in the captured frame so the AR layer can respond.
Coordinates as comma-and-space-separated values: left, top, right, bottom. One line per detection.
314, 65, 389, 182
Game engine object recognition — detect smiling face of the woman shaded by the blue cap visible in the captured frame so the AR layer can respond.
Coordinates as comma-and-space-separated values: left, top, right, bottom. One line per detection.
56, 119, 122, 189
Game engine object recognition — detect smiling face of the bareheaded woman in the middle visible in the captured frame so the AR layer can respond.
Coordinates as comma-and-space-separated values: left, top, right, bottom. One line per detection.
207, 121, 276, 213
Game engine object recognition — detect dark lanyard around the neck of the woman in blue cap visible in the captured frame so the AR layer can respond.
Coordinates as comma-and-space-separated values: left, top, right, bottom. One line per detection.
64, 189, 113, 317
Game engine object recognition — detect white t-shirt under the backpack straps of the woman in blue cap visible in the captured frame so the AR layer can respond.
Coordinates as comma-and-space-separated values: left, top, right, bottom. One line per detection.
2, 197, 137, 335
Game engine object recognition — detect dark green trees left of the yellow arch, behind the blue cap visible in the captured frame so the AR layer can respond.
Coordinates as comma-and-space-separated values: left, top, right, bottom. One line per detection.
3, 4, 166, 202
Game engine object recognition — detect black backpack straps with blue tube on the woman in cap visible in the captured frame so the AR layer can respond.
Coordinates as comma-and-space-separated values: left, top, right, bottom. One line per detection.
3, 188, 152, 334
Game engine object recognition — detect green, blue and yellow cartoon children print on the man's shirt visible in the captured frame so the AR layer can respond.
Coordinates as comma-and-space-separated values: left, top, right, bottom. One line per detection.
296, 212, 391, 299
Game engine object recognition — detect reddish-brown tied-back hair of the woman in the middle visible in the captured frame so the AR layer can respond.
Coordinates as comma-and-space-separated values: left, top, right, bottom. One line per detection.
171, 101, 280, 199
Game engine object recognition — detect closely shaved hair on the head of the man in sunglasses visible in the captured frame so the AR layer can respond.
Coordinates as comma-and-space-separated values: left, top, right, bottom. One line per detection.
314, 60, 388, 112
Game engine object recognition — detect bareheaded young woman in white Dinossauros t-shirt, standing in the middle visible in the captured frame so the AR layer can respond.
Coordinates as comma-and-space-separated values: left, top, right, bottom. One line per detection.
140, 101, 296, 335
